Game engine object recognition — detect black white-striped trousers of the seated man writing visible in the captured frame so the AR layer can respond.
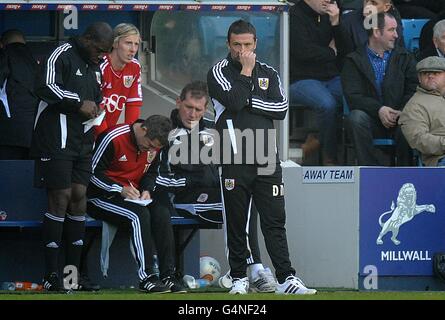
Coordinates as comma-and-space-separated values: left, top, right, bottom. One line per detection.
87, 194, 175, 280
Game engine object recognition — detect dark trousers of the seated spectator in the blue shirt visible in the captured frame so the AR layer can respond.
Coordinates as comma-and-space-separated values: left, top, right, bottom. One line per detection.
346, 110, 412, 166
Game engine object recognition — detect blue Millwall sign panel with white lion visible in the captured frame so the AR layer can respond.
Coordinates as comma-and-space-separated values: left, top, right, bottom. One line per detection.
360, 167, 445, 276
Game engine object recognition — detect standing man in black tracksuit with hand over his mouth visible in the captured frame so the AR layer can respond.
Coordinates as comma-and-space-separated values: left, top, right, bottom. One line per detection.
207, 20, 316, 294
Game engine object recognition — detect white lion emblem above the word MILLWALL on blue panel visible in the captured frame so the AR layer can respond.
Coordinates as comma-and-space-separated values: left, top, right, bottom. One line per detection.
376, 183, 436, 245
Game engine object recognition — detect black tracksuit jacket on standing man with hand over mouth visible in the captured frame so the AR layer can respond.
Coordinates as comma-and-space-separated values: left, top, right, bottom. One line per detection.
207, 54, 289, 165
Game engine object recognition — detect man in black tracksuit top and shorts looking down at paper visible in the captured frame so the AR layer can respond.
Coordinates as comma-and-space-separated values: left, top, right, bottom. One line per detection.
31, 22, 113, 291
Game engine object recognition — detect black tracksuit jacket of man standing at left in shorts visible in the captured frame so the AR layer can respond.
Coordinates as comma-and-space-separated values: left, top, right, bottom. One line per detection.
31, 38, 102, 160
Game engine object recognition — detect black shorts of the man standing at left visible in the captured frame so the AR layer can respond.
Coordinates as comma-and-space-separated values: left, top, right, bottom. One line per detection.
34, 156, 92, 189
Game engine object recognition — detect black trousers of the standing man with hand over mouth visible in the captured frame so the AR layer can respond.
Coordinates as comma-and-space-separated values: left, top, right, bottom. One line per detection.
221, 164, 295, 282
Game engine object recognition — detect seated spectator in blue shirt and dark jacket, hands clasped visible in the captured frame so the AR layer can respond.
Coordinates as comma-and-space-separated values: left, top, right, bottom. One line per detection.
341, 13, 418, 166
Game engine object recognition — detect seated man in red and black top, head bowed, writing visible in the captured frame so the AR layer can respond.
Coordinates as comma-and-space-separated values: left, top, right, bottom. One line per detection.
87, 115, 185, 293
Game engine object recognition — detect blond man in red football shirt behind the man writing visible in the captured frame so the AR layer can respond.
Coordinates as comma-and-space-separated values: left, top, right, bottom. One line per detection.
96, 23, 142, 136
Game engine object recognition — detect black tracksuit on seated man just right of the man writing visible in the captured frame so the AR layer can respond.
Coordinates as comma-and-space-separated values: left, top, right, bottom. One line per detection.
142, 109, 222, 223
